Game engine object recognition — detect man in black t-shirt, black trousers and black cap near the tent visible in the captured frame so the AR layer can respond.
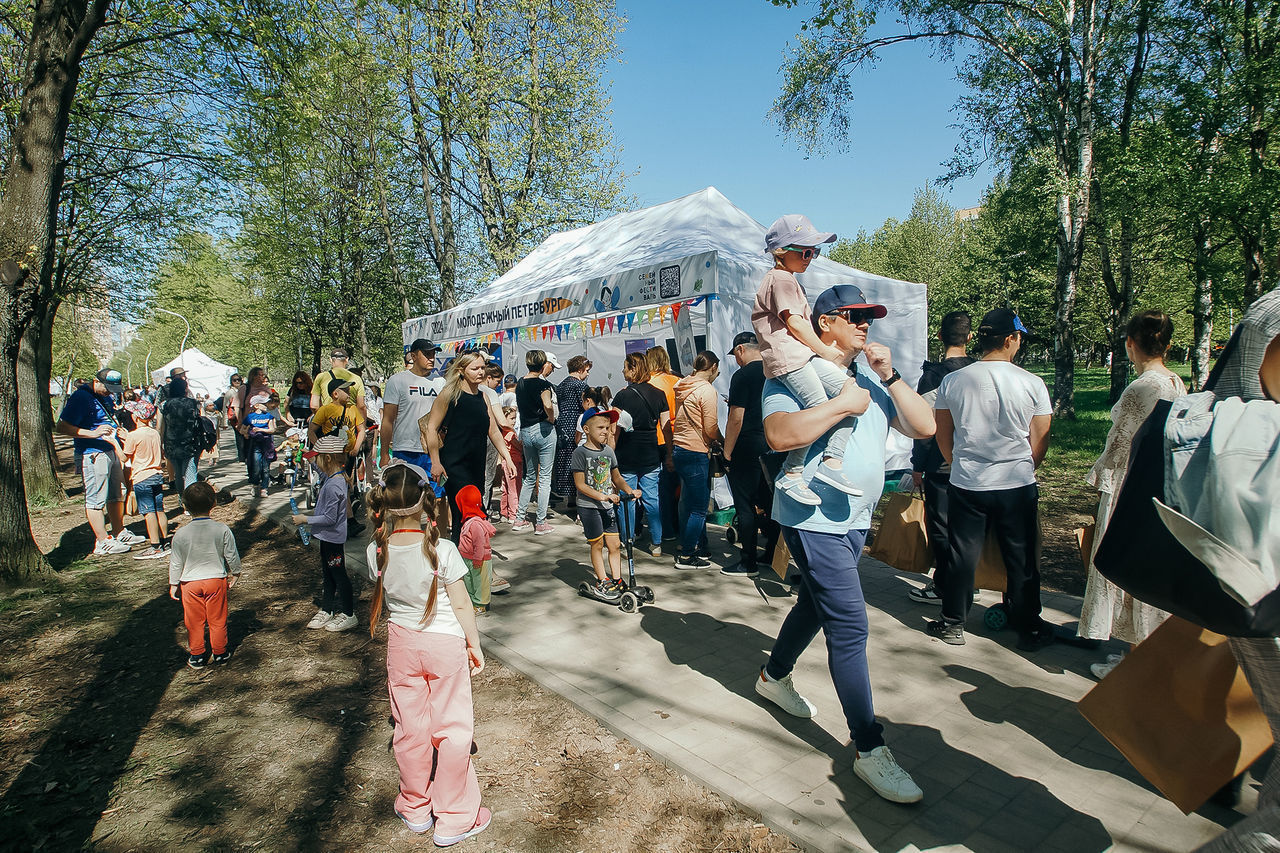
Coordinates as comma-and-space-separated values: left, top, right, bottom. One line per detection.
721, 332, 778, 578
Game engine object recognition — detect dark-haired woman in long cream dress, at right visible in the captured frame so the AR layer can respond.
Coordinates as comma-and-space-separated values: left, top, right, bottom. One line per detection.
1076, 311, 1187, 679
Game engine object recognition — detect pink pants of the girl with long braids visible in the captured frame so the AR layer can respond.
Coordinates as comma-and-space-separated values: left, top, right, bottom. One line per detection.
387, 624, 480, 835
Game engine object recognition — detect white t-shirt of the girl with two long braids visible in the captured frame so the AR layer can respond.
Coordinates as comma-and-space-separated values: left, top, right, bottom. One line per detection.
365, 535, 470, 638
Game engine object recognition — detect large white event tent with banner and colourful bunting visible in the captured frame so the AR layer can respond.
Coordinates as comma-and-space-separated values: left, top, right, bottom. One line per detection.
403, 187, 928, 470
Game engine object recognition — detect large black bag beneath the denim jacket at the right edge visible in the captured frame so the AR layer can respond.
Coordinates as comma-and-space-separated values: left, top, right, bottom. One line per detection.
1093, 400, 1280, 637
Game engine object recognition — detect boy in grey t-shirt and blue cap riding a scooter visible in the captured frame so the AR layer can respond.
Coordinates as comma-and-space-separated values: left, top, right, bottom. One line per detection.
568, 409, 640, 602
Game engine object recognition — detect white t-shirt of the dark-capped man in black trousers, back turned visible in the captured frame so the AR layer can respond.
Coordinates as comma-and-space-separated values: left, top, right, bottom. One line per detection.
933, 361, 1053, 492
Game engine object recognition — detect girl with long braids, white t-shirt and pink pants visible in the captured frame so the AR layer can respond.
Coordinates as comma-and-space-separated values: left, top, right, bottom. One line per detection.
367, 460, 492, 847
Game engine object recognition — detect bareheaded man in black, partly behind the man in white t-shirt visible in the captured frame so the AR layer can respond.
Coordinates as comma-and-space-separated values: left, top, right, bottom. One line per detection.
908, 311, 974, 605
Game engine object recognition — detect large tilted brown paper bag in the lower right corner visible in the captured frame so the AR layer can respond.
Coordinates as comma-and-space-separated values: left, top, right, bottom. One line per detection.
1078, 616, 1271, 815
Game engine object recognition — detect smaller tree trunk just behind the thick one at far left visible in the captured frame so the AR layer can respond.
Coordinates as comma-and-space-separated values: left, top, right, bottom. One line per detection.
18, 295, 65, 503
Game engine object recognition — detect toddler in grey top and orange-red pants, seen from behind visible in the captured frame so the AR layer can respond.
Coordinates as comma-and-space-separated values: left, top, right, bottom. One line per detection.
169, 480, 241, 670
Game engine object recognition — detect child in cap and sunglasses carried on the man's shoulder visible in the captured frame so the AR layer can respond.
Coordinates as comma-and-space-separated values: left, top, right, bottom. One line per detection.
751, 214, 861, 506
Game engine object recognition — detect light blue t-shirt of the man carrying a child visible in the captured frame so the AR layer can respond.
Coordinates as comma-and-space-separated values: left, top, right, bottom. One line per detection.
763, 364, 897, 535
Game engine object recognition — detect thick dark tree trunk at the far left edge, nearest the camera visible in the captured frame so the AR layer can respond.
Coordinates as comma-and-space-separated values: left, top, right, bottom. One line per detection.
0, 0, 109, 581
